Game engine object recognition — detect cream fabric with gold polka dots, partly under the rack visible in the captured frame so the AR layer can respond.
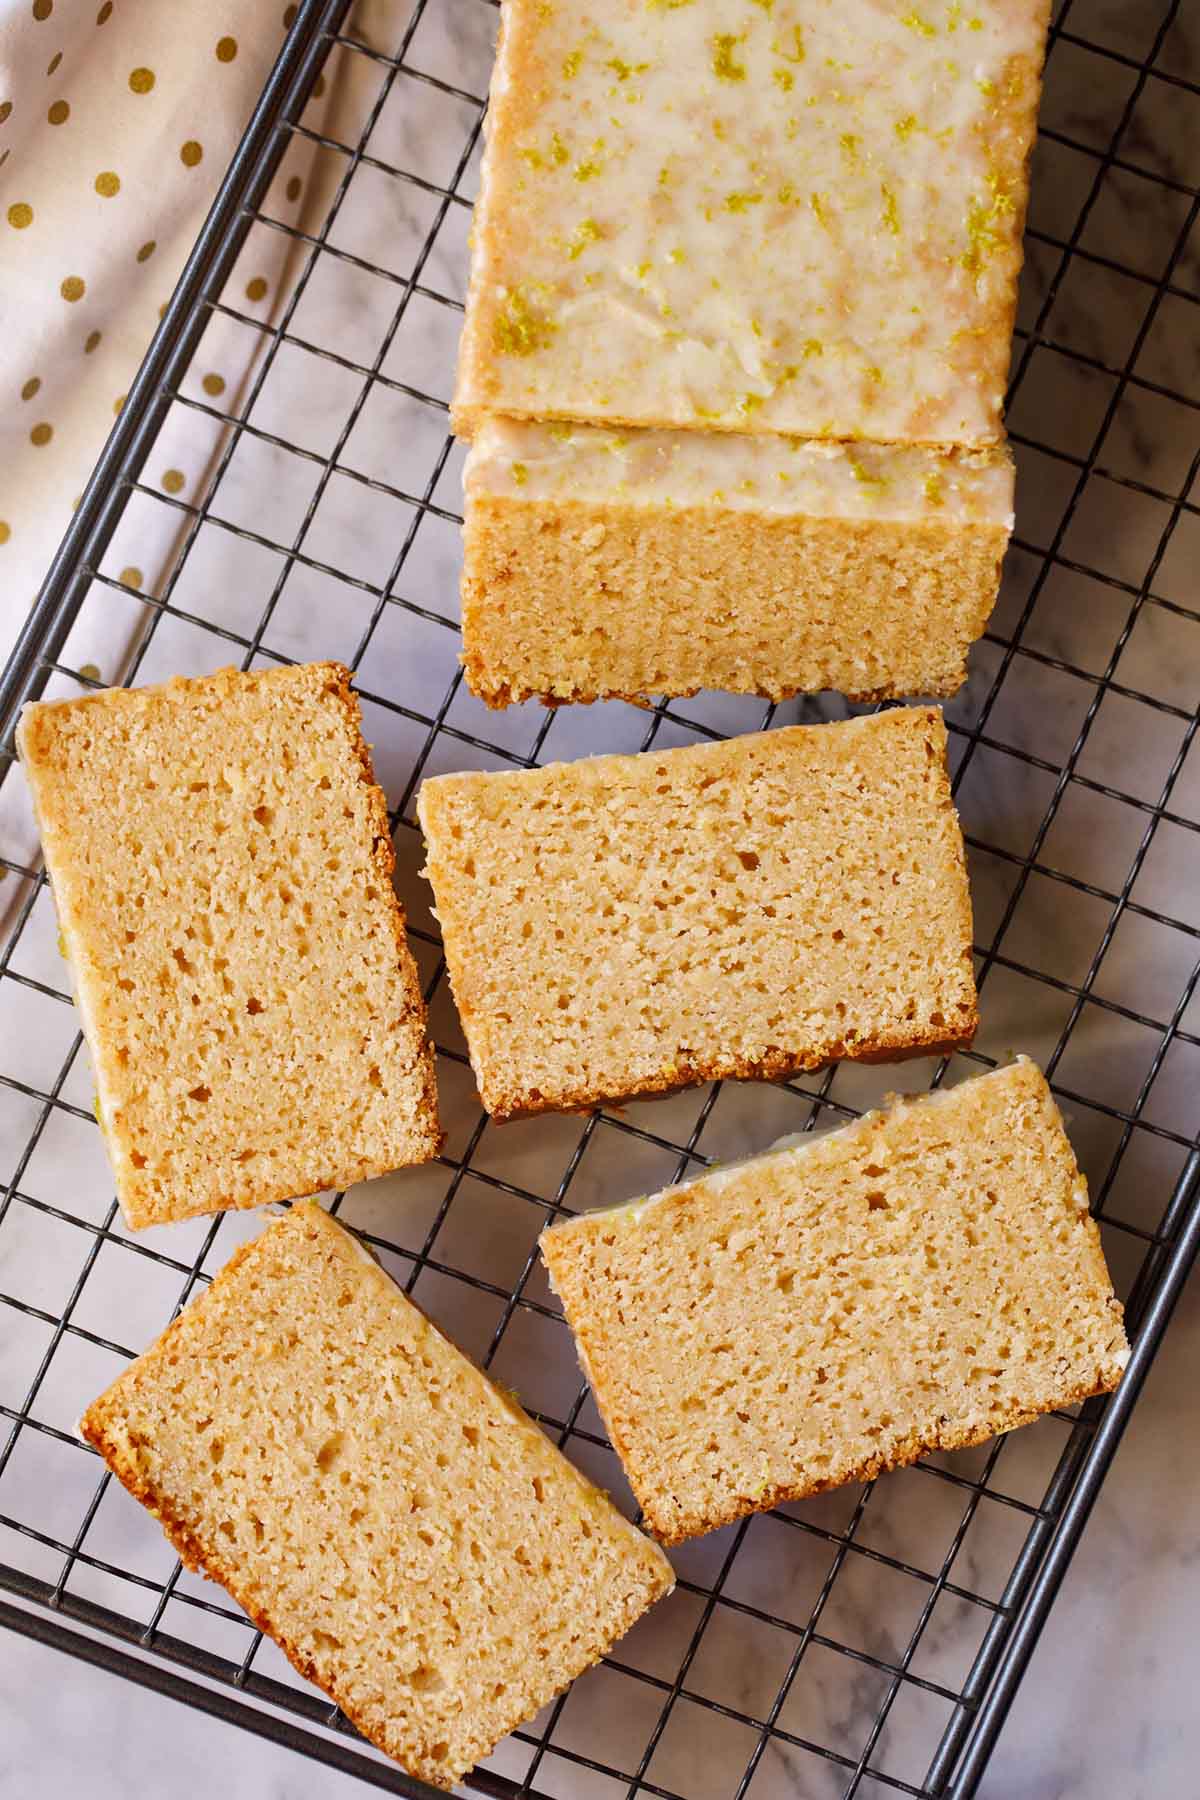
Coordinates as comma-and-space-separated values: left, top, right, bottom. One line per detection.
0, 0, 413, 922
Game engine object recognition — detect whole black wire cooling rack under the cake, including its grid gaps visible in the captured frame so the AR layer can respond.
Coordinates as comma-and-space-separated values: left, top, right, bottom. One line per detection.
0, 0, 1200, 1800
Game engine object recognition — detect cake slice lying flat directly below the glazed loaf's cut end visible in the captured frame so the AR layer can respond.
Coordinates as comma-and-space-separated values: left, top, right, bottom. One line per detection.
417, 707, 977, 1118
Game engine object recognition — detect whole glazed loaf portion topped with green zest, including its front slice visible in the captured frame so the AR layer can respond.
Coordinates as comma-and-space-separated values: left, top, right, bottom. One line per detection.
452, 0, 1049, 707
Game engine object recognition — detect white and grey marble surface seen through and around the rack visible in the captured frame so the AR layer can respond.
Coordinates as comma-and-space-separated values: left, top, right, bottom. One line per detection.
0, 0, 1200, 1800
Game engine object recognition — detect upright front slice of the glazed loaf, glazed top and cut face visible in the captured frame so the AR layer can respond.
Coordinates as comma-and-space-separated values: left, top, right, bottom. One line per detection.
462, 419, 1013, 706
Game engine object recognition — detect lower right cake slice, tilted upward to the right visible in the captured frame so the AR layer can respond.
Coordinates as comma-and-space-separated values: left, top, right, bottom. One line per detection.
542, 1058, 1128, 1543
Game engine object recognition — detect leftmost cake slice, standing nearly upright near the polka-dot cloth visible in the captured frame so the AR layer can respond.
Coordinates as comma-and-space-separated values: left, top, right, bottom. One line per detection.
18, 662, 441, 1228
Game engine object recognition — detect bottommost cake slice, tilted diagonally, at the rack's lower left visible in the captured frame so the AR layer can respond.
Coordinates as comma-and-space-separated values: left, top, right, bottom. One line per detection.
81, 1202, 673, 1787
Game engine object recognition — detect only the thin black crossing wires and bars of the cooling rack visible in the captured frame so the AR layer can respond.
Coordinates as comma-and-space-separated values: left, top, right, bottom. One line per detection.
0, 0, 1200, 1800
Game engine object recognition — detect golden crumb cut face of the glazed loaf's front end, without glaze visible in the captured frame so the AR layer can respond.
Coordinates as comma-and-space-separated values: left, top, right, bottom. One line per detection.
462, 495, 1009, 707
